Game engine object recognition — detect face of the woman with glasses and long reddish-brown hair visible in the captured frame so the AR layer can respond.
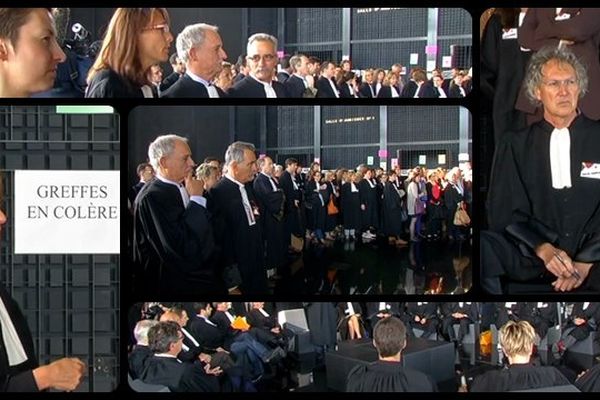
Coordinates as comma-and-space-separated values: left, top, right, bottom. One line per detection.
138, 12, 173, 68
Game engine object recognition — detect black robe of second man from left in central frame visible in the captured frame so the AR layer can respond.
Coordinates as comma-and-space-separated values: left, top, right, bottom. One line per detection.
210, 177, 267, 294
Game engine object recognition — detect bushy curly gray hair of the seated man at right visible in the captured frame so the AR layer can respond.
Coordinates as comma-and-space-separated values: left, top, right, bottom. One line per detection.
525, 46, 588, 105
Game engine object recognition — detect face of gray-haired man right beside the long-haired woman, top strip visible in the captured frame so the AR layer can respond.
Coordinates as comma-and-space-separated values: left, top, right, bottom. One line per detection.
190, 30, 227, 81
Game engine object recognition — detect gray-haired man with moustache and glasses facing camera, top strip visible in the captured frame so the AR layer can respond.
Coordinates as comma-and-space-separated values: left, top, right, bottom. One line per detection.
229, 33, 286, 98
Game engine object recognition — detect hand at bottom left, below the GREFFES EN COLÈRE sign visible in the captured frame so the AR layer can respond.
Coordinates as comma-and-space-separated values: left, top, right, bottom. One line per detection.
33, 358, 86, 392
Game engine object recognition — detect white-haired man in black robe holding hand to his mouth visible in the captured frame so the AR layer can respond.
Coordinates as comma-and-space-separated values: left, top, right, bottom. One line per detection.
133, 135, 224, 298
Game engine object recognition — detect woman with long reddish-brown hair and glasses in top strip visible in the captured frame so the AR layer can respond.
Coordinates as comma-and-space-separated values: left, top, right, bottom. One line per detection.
85, 8, 173, 98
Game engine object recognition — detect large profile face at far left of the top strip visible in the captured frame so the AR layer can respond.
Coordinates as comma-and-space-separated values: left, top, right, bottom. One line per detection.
0, 8, 65, 97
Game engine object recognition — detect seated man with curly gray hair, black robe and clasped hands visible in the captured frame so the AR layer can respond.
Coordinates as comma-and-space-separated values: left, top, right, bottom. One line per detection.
480, 47, 600, 294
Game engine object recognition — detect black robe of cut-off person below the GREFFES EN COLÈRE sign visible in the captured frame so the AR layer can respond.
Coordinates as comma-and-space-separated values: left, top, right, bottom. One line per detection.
0, 284, 38, 392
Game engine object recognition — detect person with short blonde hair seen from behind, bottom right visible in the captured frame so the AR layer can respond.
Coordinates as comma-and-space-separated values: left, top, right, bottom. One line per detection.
471, 321, 569, 392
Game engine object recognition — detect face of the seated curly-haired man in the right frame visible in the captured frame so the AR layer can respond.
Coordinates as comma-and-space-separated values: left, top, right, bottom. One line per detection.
535, 60, 580, 122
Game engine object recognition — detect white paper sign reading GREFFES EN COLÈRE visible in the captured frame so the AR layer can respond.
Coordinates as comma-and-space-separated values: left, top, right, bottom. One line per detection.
14, 171, 120, 254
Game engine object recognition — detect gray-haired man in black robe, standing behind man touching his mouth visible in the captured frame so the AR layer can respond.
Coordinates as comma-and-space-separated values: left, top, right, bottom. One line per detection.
210, 142, 267, 294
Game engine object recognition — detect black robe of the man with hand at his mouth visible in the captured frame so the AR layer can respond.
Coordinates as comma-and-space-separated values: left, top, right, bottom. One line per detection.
134, 179, 219, 296
